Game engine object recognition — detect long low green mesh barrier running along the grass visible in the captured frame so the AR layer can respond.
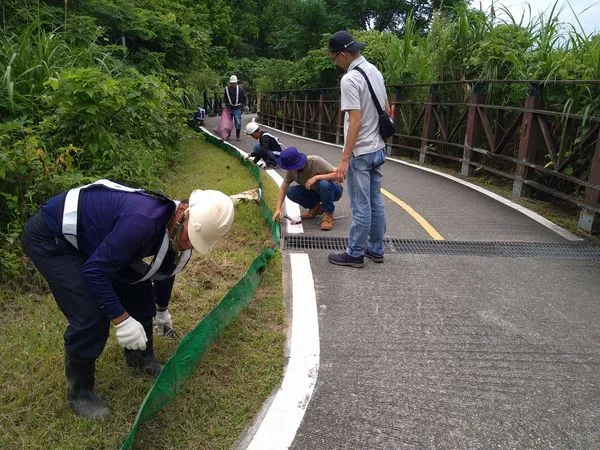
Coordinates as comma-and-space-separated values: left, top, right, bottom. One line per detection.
121, 134, 281, 450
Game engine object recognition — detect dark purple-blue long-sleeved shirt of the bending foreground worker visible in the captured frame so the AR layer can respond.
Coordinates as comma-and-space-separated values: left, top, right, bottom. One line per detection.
42, 186, 175, 319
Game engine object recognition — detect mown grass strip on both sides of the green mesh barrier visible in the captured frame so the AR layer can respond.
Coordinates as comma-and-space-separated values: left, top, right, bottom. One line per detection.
0, 138, 285, 449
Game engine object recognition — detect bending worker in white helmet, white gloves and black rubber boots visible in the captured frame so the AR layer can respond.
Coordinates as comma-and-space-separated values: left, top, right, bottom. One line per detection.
23, 180, 234, 419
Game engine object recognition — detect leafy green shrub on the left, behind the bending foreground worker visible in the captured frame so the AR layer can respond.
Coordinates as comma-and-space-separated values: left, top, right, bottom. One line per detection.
0, 67, 184, 280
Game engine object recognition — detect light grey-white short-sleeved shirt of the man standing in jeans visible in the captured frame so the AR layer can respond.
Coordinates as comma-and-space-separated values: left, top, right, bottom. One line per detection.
340, 56, 387, 156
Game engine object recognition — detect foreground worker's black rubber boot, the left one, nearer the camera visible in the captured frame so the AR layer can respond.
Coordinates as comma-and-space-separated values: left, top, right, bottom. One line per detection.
65, 355, 110, 419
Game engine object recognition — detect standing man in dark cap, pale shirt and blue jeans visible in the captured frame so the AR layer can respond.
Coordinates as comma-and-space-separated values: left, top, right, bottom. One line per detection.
329, 31, 390, 268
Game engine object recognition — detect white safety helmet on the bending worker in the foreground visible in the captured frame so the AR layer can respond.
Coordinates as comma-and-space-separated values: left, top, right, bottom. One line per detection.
188, 189, 234, 253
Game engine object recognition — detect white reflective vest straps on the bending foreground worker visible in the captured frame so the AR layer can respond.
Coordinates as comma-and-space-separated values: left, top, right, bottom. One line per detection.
62, 180, 192, 284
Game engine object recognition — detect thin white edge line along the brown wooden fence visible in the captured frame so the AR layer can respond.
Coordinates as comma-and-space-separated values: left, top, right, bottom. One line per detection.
261, 124, 583, 242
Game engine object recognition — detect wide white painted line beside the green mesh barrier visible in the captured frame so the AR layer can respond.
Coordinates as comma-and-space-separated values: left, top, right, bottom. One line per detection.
202, 127, 320, 450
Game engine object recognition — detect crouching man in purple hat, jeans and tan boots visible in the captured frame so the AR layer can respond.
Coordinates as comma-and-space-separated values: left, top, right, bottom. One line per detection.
273, 147, 343, 231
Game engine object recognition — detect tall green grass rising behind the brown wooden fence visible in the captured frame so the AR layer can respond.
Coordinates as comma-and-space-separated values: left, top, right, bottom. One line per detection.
284, 4, 600, 90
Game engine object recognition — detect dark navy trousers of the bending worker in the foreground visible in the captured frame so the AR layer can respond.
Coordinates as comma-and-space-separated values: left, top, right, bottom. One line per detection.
23, 210, 156, 361
